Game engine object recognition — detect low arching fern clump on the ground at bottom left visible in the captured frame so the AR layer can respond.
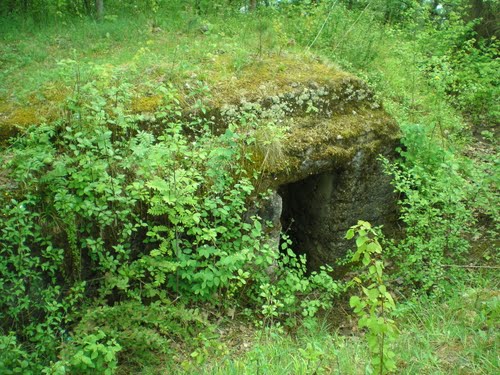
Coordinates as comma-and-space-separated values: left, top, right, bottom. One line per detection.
52, 301, 214, 373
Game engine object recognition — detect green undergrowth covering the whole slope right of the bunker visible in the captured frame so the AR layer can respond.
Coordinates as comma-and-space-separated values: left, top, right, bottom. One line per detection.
287, 1, 499, 294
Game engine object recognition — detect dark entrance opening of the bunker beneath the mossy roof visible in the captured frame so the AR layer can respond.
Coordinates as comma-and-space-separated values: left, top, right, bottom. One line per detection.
278, 165, 379, 271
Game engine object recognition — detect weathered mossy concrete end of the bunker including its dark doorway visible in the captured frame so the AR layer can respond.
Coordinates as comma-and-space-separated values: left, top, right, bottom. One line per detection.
213, 56, 400, 270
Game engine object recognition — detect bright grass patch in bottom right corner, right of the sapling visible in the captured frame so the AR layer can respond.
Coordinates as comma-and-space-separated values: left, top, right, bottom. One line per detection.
397, 270, 499, 374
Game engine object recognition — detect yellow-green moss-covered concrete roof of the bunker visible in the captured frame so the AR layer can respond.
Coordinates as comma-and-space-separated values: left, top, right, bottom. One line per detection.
0, 54, 397, 158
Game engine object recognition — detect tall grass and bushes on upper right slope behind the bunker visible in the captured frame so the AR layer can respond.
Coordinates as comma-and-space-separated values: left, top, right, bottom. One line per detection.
281, 0, 500, 125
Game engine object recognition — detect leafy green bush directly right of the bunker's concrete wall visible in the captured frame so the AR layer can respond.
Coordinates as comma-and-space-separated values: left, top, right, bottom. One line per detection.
384, 126, 481, 292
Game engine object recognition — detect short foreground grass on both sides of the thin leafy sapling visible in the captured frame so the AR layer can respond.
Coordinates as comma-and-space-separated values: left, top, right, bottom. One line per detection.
159, 274, 500, 375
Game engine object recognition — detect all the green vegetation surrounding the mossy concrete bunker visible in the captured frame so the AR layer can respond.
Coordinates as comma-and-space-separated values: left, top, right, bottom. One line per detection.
0, 0, 500, 374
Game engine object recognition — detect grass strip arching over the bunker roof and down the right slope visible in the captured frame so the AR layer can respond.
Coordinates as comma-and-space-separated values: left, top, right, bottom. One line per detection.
0, 2, 470, 138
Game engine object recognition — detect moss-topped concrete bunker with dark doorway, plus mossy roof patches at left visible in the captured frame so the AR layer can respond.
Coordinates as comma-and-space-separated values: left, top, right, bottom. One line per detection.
0, 54, 400, 270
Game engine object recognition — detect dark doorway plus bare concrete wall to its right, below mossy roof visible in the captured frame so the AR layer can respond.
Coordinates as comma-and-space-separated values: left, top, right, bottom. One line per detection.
277, 153, 397, 270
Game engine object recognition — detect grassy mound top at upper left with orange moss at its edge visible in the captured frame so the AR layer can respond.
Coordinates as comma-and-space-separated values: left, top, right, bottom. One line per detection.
0, 9, 312, 134
